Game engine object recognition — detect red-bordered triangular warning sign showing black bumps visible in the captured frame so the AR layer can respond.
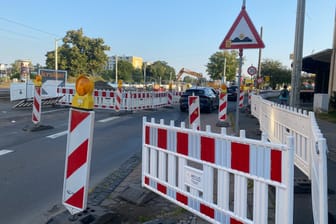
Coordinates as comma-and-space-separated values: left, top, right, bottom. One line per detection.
219, 7, 265, 49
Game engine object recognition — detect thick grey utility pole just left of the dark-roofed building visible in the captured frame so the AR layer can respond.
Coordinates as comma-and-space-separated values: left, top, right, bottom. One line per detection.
290, 0, 306, 107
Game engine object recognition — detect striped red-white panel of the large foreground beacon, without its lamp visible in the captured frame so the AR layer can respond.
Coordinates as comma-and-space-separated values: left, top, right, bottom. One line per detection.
63, 108, 94, 214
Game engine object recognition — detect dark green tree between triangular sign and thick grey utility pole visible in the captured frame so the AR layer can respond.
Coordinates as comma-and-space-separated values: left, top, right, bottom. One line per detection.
260, 59, 291, 89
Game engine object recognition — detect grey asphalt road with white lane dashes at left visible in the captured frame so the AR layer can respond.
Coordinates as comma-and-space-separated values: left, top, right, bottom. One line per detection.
0, 99, 233, 224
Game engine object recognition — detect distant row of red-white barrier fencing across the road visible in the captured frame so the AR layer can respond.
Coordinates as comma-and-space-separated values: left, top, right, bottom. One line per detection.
57, 87, 181, 110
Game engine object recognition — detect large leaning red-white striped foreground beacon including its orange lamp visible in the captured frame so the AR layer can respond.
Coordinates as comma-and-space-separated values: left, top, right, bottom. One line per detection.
62, 76, 94, 215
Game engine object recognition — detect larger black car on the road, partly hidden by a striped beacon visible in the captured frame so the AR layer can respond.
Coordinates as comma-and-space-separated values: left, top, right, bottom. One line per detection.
180, 86, 219, 113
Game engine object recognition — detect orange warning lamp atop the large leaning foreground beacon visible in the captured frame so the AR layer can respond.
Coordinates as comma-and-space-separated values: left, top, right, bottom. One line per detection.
72, 75, 93, 110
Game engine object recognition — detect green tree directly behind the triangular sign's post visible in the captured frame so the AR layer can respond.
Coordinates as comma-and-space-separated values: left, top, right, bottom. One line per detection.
206, 50, 239, 81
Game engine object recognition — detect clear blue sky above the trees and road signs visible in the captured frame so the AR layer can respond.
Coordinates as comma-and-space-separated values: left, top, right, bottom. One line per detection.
0, 0, 336, 78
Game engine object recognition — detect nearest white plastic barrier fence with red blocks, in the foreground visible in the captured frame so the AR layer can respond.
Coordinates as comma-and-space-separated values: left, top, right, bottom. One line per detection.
142, 117, 294, 224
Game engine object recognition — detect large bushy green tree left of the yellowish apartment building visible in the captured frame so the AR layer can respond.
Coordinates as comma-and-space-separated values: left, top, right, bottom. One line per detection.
46, 29, 110, 76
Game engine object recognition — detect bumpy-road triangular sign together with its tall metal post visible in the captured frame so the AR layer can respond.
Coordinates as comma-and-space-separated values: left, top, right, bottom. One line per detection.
219, 1, 265, 135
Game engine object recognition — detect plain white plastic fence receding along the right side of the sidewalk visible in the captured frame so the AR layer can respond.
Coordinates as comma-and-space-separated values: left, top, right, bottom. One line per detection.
251, 95, 328, 224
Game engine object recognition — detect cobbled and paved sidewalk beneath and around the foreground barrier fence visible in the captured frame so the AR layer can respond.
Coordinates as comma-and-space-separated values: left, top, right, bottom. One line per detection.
47, 106, 336, 224
